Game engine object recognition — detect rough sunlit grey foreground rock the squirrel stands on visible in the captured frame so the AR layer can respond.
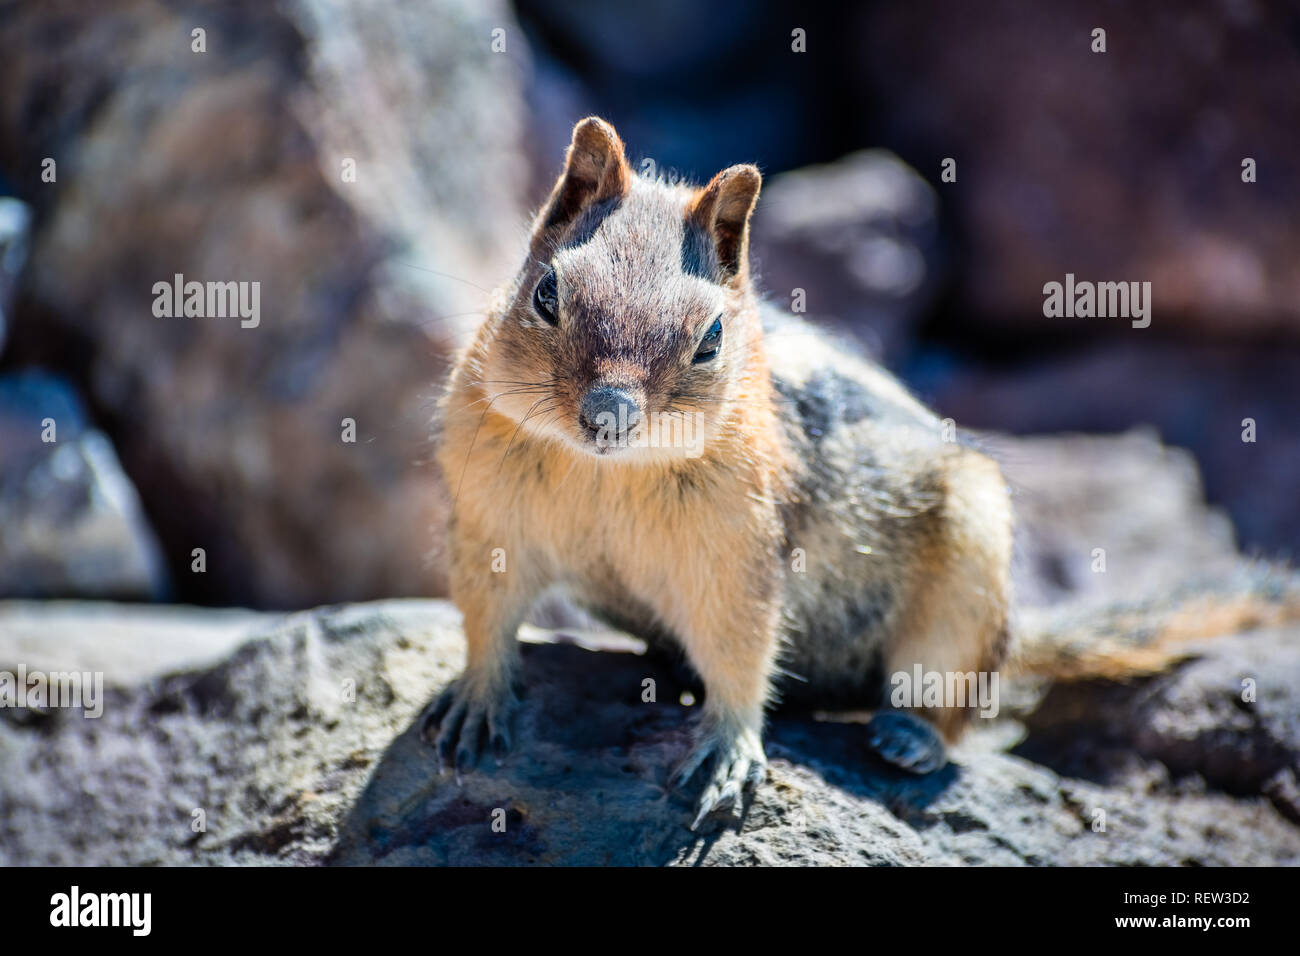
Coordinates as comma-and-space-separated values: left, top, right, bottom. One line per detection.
0, 434, 1300, 865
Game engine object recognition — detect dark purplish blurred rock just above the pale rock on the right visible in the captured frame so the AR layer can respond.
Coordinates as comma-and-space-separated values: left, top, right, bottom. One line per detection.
907, 341, 1300, 559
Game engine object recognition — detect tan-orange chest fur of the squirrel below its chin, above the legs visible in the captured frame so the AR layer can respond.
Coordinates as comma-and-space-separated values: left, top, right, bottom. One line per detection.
441, 389, 780, 650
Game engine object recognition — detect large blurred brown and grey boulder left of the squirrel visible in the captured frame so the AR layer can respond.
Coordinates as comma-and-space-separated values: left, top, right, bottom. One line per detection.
0, 0, 527, 606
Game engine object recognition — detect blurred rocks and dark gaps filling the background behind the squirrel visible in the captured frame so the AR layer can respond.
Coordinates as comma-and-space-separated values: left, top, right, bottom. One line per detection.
0, 0, 1300, 607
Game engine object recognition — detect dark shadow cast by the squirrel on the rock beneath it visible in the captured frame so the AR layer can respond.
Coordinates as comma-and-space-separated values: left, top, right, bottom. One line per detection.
330, 634, 958, 866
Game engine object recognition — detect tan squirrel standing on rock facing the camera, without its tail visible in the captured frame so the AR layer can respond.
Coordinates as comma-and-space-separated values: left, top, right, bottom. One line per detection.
425, 117, 1011, 829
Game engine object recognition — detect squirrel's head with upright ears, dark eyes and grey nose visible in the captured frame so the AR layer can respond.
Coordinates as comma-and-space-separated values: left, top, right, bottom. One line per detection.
484, 117, 762, 460
